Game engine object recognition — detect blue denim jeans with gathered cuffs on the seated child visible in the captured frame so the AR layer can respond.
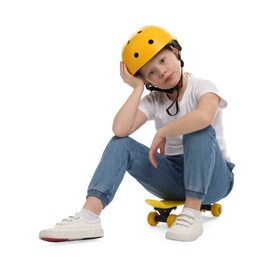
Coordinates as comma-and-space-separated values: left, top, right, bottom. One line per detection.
87, 126, 234, 207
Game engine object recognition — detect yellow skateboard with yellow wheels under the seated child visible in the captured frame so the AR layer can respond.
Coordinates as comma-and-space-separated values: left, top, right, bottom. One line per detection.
145, 199, 222, 227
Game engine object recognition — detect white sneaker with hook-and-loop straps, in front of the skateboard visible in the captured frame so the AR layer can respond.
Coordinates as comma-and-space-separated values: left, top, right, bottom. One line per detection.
166, 210, 203, 242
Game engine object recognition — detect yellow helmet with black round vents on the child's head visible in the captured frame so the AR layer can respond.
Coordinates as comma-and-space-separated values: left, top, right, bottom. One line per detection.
122, 26, 181, 75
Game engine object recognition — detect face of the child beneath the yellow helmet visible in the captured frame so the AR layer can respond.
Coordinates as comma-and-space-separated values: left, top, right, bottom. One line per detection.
140, 48, 181, 89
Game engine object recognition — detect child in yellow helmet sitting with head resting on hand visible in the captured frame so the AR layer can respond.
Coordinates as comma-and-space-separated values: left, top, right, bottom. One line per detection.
39, 26, 234, 242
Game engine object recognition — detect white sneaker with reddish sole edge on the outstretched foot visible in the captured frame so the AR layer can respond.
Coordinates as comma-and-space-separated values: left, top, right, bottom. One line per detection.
39, 214, 104, 242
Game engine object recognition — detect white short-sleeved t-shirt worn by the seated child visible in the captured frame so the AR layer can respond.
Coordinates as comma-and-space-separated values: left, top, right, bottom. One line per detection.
139, 76, 230, 161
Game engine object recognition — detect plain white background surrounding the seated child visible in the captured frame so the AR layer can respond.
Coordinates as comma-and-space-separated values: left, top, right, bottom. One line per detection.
0, 0, 279, 259
